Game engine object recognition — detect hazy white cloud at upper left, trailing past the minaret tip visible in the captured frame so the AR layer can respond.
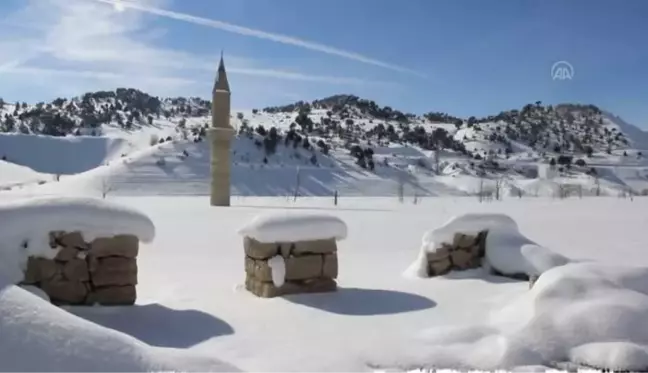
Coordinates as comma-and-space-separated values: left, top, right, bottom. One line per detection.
0, 0, 384, 100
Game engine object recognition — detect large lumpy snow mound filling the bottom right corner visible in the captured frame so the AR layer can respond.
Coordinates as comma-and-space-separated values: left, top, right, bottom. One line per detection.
378, 262, 648, 370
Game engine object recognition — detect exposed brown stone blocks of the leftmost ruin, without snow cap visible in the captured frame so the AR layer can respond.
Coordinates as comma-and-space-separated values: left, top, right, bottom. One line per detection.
22, 232, 139, 305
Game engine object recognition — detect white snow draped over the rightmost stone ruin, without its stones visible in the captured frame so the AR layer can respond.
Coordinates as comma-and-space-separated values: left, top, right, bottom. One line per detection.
405, 214, 570, 278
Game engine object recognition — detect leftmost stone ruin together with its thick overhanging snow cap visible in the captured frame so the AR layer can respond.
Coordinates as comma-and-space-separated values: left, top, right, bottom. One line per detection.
0, 198, 155, 305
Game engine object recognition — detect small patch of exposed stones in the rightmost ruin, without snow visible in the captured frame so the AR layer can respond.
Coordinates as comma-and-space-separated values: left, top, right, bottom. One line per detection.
427, 231, 488, 277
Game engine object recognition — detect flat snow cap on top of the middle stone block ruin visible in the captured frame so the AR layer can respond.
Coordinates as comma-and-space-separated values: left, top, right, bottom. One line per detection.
239, 211, 347, 243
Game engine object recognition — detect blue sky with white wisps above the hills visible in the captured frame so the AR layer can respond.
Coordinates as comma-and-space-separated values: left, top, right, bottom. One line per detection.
0, 0, 648, 129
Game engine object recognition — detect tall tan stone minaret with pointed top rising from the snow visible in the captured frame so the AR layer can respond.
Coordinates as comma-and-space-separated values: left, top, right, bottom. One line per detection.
207, 52, 234, 206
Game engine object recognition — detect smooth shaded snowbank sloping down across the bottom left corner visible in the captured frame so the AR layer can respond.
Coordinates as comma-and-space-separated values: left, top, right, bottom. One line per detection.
0, 279, 240, 373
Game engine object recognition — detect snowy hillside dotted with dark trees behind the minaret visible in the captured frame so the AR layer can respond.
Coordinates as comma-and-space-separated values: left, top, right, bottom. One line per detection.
0, 89, 648, 197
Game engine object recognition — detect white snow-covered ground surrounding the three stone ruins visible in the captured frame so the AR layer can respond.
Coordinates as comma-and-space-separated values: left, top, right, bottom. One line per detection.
0, 195, 648, 373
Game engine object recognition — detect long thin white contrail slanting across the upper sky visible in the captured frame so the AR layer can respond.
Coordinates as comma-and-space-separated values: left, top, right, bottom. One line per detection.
94, 0, 425, 77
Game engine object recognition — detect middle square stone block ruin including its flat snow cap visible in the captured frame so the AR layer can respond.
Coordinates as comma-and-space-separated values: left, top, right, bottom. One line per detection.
239, 213, 347, 298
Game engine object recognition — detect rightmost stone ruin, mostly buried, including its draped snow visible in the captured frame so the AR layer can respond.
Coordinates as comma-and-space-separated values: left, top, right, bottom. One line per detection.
406, 214, 569, 286
